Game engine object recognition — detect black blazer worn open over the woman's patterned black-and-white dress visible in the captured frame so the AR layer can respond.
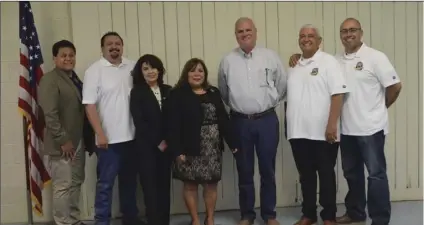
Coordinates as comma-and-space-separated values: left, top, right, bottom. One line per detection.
168, 85, 236, 157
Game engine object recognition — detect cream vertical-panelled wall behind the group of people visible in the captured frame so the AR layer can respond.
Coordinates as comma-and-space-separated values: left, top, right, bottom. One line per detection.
71, 2, 422, 217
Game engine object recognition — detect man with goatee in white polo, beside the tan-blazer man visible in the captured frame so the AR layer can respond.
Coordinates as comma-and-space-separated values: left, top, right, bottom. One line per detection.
82, 32, 140, 225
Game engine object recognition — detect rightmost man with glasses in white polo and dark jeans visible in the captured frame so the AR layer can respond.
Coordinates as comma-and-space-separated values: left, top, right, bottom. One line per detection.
290, 18, 402, 225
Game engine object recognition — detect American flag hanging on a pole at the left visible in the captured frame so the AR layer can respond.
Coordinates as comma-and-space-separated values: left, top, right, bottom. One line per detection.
18, 2, 51, 215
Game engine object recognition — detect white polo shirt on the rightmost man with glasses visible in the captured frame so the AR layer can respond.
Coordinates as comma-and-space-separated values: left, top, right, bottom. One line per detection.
337, 43, 400, 136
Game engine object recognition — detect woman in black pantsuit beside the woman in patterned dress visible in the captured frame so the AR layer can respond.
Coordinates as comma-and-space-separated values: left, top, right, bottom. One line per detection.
130, 54, 172, 225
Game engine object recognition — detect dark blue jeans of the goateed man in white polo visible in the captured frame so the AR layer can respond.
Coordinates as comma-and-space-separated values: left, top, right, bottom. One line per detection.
94, 141, 138, 225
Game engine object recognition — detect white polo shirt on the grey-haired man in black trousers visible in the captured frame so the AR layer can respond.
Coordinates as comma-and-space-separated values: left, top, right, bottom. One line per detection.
286, 50, 349, 141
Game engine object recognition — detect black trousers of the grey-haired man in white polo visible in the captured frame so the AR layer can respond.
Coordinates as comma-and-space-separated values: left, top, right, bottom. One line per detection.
290, 139, 339, 221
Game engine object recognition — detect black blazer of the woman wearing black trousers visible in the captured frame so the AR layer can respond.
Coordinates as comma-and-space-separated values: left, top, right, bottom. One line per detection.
130, 84, 171, 149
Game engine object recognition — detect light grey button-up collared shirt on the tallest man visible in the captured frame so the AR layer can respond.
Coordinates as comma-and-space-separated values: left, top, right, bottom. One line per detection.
218, 47, 287, 114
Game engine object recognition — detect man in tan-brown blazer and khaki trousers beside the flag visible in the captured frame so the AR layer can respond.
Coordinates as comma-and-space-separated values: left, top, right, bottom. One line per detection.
38, 40, 92, 225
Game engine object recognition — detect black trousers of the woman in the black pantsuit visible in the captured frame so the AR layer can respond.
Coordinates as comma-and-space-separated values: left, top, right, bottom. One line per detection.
138, 146, 172, 225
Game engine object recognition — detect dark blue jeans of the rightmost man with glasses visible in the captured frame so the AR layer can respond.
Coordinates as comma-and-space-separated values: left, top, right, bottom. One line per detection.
340, 131, 391, 225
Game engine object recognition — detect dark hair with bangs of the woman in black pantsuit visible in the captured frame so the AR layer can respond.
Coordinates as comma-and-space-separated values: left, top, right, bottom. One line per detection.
131, 54, 165, 85
